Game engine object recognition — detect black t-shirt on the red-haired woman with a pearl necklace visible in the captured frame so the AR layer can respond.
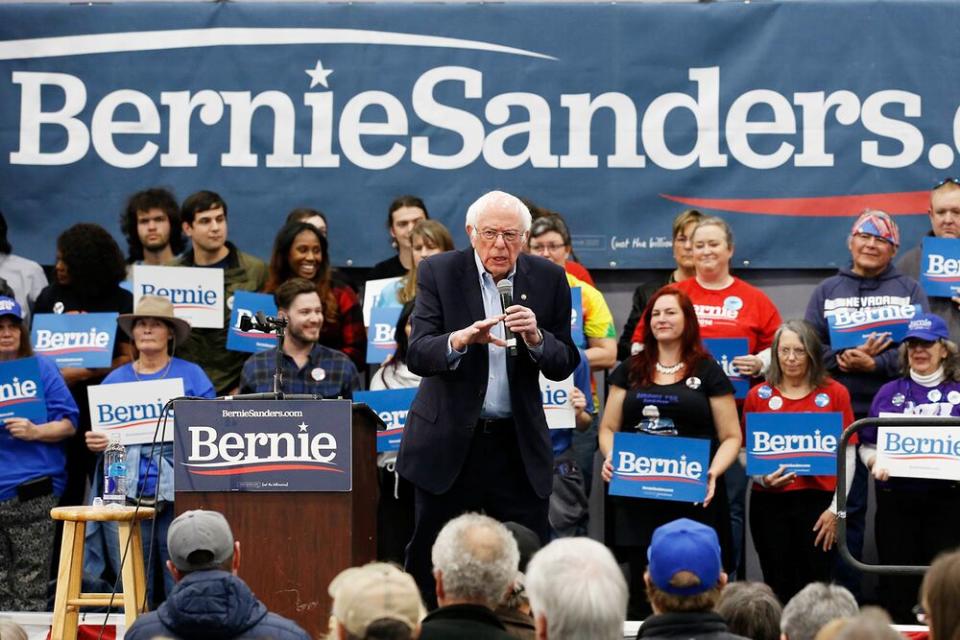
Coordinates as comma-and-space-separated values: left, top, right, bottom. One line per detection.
609, 357, 733, 440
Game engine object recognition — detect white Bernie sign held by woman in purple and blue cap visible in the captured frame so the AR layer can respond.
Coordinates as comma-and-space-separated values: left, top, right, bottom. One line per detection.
877, 420, 960, 480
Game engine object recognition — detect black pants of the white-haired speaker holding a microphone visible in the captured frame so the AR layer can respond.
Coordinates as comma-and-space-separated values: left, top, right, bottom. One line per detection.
405, 421, 550, 609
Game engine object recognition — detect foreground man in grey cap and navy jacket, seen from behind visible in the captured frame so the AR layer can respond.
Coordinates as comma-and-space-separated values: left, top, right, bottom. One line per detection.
124, 509, 310, 640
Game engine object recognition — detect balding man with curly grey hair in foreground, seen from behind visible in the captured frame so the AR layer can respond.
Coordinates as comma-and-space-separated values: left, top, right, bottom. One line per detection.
420, 513, 520, 640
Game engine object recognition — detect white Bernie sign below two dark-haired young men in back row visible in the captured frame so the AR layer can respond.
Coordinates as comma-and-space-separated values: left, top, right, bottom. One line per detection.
133, 264, 223, 329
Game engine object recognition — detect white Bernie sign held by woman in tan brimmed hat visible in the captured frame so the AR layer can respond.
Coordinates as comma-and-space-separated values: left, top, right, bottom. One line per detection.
87, 378, 183, 445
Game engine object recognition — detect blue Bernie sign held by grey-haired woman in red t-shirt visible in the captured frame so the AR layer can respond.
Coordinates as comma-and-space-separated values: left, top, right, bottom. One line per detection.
746, 412, 843, 476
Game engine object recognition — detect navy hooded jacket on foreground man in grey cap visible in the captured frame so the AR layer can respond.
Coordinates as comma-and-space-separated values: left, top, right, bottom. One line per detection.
124, 570, 310, 640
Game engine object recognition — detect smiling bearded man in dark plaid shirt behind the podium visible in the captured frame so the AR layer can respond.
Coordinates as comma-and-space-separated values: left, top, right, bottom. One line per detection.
240, 278, 360, 398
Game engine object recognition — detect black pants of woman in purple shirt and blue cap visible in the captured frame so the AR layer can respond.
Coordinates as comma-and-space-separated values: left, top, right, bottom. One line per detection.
874, 483, 960, 624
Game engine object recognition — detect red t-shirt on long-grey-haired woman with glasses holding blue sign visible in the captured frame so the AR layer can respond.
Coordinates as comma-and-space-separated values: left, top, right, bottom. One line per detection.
742, 379, 857, 493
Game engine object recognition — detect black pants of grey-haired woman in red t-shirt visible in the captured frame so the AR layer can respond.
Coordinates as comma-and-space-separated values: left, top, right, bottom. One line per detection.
750, 489, 836, 604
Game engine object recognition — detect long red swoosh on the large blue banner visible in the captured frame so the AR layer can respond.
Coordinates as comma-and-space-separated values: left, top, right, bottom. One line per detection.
660, 191, 930, 218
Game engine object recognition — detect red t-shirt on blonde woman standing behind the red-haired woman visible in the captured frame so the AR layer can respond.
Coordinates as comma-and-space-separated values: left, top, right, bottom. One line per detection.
631, 278, 781, 355
